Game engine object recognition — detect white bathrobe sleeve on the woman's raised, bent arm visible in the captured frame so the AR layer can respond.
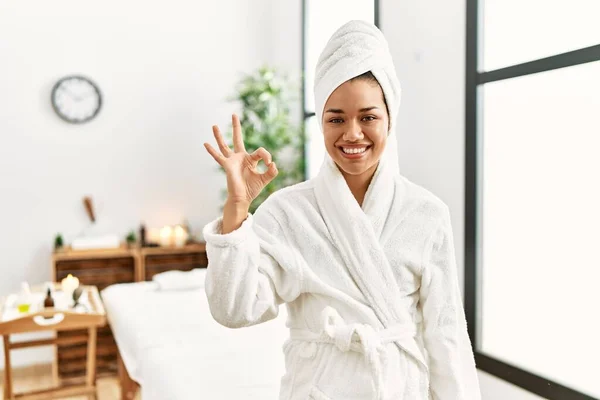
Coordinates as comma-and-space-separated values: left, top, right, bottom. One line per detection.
203, 202, 302, 328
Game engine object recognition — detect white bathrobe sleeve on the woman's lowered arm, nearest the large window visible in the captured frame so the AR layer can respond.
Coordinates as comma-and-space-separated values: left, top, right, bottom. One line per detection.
419, 206, 481, 400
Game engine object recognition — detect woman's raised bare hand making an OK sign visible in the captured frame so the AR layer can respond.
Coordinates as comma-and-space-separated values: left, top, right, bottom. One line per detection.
204, 114, 278, 207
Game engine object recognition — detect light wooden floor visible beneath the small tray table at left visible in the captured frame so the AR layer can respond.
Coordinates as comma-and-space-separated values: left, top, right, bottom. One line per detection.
0, 365, 140, 400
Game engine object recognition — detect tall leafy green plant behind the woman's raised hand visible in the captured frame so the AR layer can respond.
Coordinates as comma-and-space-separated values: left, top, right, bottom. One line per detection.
224, 66, 305, 213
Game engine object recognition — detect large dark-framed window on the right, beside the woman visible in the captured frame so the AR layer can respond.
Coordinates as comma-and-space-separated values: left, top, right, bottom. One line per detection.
465, 0, 600, 400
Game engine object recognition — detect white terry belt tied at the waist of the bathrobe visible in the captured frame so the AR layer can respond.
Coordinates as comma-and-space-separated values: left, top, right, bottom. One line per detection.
290, 307, 417, 400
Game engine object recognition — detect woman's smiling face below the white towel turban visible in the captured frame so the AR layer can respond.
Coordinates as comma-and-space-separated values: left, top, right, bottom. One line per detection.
323, 79, 389, 177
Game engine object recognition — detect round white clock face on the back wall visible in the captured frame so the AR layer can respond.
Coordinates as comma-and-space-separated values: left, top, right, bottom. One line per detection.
51, 76, 102, 124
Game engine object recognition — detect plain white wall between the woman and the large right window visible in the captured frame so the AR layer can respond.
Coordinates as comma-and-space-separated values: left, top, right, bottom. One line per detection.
380, 0, 540, 400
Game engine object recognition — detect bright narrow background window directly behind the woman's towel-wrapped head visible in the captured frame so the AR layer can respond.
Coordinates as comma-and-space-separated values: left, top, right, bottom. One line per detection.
302, 0, 378, 178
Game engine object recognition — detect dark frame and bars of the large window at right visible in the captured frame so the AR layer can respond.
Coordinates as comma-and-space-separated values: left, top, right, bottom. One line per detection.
465, 0, 600, 400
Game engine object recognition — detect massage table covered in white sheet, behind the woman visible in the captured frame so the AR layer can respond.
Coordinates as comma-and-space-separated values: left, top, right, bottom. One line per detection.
102, 282, 288, 400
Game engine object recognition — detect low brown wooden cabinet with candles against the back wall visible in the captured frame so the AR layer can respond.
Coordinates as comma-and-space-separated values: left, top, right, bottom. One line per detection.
52, 243, 208, 382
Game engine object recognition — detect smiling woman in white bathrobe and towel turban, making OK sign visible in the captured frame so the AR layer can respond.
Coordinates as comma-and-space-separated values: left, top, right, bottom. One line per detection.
204, 21, 480, 400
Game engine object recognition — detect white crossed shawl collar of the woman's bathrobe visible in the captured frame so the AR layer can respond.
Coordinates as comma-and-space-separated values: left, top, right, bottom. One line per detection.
315, 141, 427, 369
